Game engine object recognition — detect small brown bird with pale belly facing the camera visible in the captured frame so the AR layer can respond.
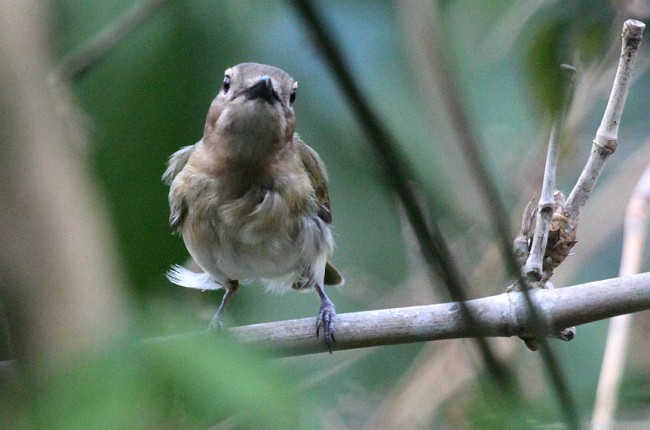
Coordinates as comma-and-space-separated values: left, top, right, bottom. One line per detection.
163, 63, 343, 352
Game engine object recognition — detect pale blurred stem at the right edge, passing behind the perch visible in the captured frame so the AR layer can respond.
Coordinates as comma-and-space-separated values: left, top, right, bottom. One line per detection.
591, 165, 650, 430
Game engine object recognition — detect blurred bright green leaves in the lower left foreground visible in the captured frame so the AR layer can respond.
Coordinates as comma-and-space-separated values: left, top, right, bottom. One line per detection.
17, 330, 310, 429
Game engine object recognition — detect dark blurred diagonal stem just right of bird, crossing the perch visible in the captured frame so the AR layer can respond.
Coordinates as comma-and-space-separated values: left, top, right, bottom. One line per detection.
291, 0, 512, 388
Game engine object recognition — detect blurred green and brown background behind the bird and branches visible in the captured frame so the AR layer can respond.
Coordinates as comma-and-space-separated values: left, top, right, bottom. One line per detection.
0, 0, 650, 429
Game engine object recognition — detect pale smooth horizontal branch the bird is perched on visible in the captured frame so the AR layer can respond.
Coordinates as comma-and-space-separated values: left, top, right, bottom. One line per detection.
148, 273, 650, 356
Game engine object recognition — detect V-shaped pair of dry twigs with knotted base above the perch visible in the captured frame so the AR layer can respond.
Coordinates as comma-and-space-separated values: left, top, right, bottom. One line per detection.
509, 19, 645, 349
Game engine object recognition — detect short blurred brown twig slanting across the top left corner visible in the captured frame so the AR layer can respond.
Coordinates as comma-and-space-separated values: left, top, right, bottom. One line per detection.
50, 0, 167, 83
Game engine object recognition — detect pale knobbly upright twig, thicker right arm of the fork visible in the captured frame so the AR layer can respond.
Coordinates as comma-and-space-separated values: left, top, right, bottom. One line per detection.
564, 19, 645, 225
